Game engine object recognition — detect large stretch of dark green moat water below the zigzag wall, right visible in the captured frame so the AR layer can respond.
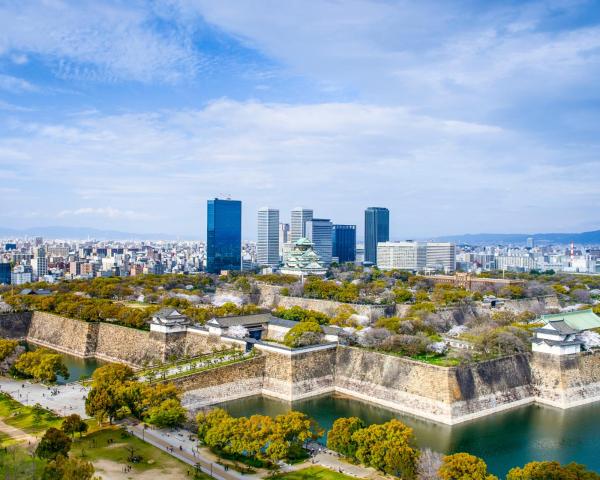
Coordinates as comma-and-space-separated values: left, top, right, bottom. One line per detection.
219, 395, 600, 475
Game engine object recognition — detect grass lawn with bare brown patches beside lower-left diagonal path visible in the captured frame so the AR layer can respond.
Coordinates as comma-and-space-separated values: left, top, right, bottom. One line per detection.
71, 427, 210, 479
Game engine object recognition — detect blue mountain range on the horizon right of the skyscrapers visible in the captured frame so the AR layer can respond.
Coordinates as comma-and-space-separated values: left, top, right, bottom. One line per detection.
435, 230, 600, 245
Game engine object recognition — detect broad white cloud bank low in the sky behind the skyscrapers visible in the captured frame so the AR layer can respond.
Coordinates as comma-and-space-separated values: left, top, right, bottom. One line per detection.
0, 100, 600, 238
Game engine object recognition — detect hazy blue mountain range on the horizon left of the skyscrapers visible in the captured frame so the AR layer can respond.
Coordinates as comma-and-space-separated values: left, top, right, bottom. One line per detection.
0, 226, 191, 240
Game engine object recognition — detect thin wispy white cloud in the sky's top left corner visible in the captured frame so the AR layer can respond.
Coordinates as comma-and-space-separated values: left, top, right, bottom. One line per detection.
0, 0, 200, 82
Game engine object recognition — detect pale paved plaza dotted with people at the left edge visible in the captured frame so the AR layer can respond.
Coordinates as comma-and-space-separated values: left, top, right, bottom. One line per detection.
0, 377, 89, 418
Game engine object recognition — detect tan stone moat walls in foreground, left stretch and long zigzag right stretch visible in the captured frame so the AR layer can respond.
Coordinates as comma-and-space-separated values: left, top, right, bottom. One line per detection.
0, 312, 600, 424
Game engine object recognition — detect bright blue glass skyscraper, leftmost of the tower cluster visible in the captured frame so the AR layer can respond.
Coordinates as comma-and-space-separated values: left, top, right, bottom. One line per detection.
206, 198, 242, 273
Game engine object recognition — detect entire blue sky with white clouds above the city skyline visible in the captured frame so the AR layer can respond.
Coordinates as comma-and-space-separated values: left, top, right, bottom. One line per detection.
0, 0, 600, 239
